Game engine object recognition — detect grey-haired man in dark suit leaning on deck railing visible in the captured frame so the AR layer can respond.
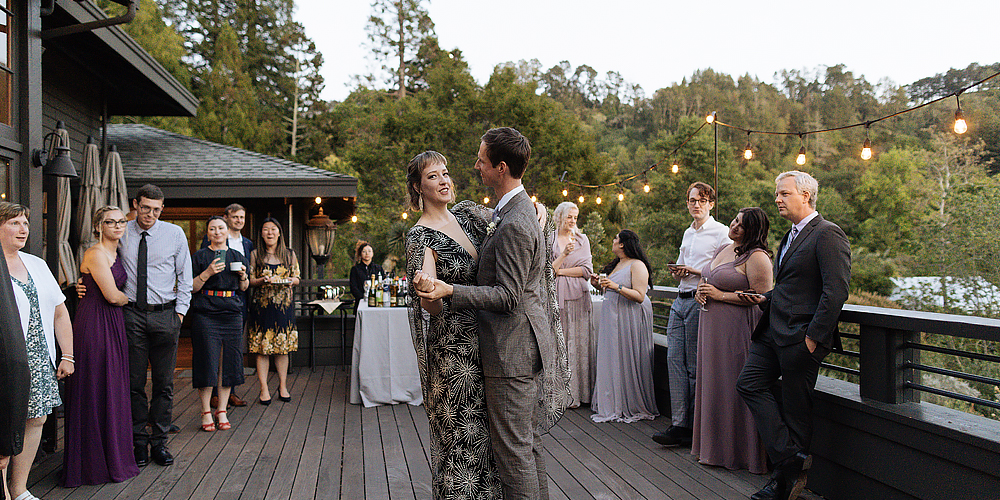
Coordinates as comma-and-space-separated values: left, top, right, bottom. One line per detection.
737, 170, 851, 500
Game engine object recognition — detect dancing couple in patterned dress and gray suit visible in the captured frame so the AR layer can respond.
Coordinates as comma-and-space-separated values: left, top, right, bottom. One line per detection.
406, 127, 569, 500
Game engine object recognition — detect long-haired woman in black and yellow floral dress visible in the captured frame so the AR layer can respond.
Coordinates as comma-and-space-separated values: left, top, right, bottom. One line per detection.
247, 217, 299, 405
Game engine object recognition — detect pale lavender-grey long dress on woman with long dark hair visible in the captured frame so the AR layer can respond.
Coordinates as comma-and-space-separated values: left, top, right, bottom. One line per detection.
590, 261, 659, 423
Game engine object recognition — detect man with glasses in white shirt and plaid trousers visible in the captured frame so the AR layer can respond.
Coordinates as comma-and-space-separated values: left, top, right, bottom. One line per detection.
653, 182, 732, 446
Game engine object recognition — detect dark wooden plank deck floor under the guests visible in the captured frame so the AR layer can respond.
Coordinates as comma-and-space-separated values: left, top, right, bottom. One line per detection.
29, 367, 818, 500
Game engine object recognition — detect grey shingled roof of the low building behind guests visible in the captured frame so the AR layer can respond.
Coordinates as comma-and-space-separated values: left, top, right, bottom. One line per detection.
108, 124, 358, 199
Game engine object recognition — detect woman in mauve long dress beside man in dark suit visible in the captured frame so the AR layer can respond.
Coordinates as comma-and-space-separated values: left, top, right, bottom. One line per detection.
691, 207, 773, 474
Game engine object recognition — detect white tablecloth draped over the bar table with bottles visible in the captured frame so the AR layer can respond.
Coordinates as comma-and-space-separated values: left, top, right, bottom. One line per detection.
351, 301, 424, 407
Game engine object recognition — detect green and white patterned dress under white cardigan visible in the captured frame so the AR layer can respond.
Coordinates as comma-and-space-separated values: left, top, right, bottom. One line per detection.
10, 273, 62, 418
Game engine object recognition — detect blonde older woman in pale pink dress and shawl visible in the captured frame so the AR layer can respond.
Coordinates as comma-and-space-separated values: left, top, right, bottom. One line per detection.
551, 201, 596, 408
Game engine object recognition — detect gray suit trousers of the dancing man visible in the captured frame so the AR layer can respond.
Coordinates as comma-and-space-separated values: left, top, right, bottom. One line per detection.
483, 374, 549, 500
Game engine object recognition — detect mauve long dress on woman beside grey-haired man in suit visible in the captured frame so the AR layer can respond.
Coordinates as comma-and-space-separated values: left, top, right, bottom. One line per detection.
691, 247, 767, 474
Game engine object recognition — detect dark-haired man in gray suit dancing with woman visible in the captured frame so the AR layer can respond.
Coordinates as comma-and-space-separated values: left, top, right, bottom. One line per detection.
413, 127, 555, 500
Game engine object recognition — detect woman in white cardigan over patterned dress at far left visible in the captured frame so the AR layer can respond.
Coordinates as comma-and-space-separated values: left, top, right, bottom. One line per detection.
0, 201, 75, 499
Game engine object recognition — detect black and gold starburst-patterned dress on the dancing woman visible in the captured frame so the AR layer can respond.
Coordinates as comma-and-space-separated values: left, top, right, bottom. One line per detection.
406, 201, 502, 500
